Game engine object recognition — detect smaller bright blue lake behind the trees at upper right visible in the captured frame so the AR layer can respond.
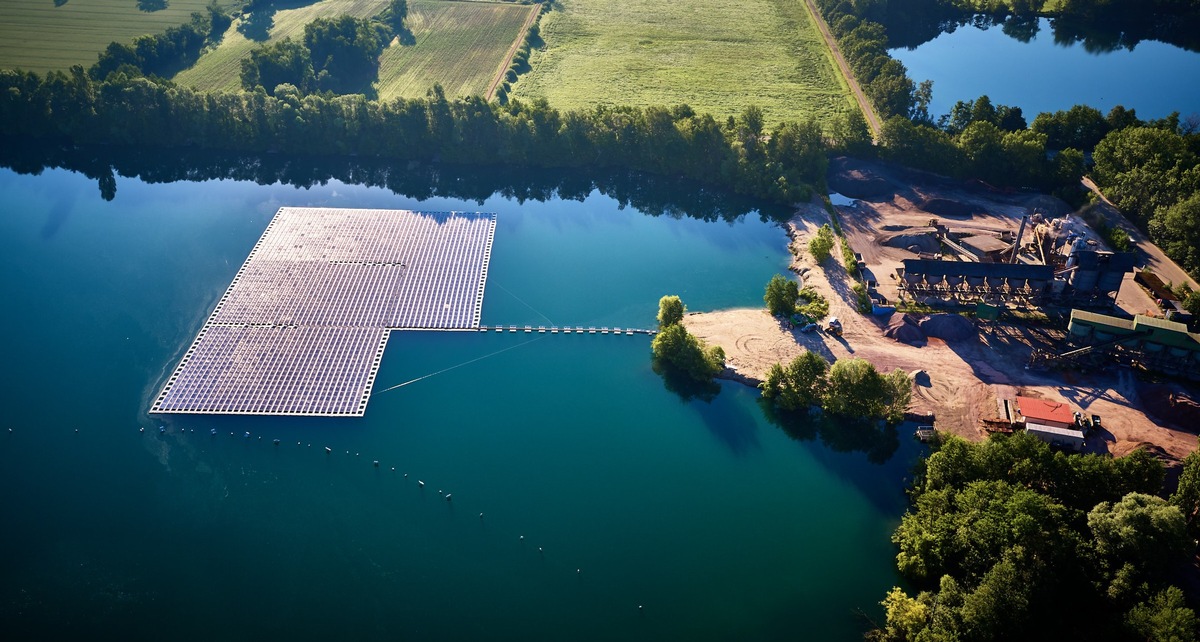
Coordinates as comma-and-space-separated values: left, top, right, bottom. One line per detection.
889, 18, 1200, 122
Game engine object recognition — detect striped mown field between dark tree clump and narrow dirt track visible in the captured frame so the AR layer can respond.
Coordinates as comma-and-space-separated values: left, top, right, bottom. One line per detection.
376, 0, 538, 98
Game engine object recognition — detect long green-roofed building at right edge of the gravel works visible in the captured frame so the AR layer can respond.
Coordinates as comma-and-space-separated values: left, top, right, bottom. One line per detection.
1067, 310, 1200, 378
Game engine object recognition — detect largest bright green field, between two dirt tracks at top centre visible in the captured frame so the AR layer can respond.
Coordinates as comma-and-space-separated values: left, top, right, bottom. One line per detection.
512, 0, 854, 126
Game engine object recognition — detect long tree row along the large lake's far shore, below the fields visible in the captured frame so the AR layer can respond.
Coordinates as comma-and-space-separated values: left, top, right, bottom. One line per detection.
0, 66, 827, 203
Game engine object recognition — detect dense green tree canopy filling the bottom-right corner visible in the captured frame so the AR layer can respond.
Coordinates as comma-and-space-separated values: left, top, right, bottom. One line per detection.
869, 432, 1200, 642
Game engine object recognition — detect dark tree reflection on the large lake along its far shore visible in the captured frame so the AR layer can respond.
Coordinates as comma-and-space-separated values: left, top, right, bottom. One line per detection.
0, 140, 791, 222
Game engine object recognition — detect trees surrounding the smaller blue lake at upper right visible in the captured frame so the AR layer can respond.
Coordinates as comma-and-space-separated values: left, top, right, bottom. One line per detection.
817, 0, 1200, 275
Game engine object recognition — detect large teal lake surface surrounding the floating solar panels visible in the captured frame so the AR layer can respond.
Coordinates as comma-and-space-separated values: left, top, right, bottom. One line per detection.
0, 170, 916, 640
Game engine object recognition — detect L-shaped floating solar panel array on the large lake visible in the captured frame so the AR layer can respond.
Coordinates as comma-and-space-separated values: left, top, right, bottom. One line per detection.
150, 208, 496, 416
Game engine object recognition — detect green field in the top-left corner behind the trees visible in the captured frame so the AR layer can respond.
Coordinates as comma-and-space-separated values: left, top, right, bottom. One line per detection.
0, 0, 236, 73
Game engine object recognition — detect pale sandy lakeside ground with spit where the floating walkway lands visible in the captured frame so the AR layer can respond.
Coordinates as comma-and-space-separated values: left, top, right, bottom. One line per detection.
684, 204, 1196, 461
